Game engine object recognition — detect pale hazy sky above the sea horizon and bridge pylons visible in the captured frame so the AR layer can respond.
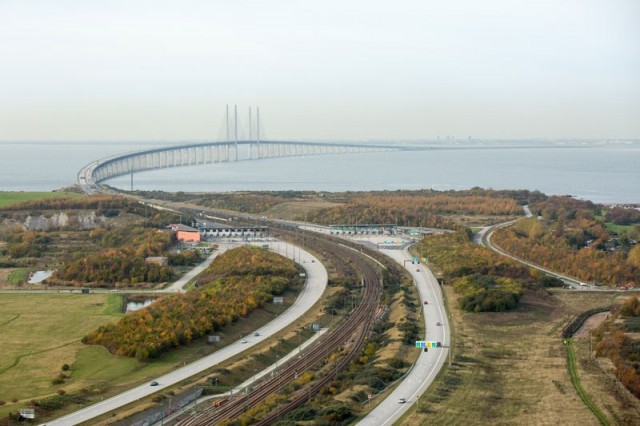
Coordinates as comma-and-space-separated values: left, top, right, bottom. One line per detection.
0, 0, 640, 141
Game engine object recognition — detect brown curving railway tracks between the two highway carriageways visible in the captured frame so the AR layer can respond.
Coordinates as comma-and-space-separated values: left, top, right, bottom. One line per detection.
177, 230, 382, 426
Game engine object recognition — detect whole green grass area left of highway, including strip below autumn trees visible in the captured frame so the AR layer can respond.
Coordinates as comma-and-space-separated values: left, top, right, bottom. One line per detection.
0, 292, 297, 418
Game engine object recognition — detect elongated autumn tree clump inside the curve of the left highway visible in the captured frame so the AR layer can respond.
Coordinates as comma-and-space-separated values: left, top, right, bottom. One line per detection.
82, 247, 300, 361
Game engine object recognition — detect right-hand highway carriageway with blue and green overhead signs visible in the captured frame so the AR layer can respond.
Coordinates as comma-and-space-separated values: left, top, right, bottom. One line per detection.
358, 249, 451, 426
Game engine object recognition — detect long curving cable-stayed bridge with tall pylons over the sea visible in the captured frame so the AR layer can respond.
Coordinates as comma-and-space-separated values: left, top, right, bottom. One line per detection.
78, 108, 426, 194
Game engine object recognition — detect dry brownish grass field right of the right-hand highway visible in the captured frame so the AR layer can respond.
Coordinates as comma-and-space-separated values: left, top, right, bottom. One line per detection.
403, 287, 640, 425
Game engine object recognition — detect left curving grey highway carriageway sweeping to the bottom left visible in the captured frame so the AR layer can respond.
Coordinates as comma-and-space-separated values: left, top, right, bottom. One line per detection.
46, 242, 328, 425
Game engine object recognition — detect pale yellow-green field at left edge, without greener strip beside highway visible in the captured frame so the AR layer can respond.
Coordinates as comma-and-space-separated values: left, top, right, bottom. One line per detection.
0, 294, 119, 411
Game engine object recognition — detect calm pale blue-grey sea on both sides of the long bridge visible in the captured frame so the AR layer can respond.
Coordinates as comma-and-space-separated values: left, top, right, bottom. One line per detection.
0, 143, 640, 203
